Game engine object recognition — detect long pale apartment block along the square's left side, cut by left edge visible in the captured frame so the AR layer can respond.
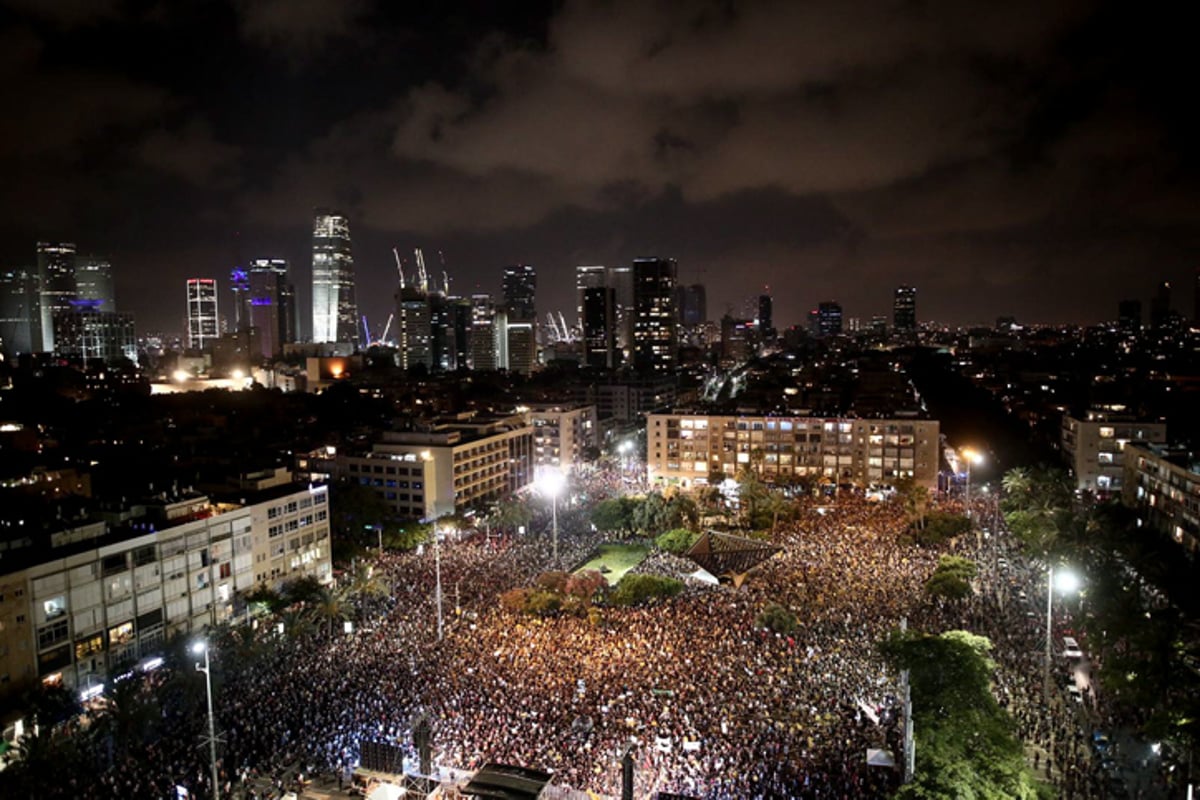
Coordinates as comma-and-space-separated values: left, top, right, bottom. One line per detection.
0, 481, 331, 699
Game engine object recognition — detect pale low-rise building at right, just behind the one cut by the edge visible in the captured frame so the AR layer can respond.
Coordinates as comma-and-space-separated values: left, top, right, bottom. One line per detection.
1062, 411, 1166, 494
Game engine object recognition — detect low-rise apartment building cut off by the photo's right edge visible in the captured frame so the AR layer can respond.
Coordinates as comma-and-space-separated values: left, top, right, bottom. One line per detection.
1121, 443, 1200, 553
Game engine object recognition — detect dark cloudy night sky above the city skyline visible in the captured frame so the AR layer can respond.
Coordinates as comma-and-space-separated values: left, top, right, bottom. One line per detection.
0, 0, 1200, 335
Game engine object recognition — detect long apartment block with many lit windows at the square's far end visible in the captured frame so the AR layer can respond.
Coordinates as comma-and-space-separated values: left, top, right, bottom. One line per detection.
646, 410, 938, 488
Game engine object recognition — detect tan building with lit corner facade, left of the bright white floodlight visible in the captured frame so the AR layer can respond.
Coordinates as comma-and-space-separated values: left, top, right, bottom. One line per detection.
334, 413, 534, 519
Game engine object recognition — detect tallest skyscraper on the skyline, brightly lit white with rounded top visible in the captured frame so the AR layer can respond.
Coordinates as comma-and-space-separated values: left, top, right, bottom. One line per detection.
312, 209, 359, 343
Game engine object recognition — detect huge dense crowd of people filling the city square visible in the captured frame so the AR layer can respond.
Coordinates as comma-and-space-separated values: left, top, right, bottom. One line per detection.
2, 479, 1142, 800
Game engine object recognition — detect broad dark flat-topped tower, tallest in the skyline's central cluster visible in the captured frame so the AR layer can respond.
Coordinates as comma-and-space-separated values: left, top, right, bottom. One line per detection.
634, 258, 678, 372
